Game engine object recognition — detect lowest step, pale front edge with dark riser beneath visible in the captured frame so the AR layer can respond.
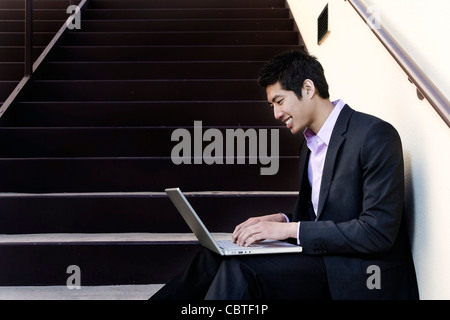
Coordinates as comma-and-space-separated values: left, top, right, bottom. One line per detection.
0, 233, 231, 287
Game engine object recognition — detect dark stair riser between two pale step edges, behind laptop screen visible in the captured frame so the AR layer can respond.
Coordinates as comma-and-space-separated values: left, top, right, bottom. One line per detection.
0, 193, 297, 234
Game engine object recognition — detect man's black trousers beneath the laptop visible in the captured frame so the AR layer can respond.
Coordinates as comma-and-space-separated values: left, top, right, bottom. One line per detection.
150, 248, 331, 300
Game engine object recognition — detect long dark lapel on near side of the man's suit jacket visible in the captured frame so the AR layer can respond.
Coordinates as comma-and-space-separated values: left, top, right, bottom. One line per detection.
316, 105, 353, 220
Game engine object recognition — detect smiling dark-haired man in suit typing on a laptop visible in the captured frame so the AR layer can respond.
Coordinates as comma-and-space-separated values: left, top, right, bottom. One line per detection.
153, 51, 418, 300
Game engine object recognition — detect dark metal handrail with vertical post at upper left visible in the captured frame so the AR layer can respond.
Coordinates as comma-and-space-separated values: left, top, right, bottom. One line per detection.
0, 0, 89, 118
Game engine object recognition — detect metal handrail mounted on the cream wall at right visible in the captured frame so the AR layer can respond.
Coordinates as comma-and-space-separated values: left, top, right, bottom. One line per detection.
345, 0, 450, 127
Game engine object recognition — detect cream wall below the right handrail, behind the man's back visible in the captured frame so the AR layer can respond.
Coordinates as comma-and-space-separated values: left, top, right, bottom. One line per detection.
288, 0, 450, 300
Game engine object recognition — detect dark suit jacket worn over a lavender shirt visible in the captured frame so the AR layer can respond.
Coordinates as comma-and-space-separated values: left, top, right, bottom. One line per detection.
292, 105, 418, 299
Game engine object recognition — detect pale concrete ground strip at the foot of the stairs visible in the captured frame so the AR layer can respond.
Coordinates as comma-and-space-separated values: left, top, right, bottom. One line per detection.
0, 284, 163, 300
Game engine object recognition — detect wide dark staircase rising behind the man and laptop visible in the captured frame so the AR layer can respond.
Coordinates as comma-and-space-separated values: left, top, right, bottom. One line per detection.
0, 0, 303, 294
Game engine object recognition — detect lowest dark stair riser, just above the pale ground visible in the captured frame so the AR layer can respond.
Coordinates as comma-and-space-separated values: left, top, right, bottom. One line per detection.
0, 243, 200, 287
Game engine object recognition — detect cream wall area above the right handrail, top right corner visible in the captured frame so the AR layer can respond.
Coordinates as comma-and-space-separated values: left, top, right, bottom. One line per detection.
363, 0, 450, 99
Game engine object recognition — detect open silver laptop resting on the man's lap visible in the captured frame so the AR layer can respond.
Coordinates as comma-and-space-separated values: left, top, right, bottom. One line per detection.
165, 188, 302, 256
